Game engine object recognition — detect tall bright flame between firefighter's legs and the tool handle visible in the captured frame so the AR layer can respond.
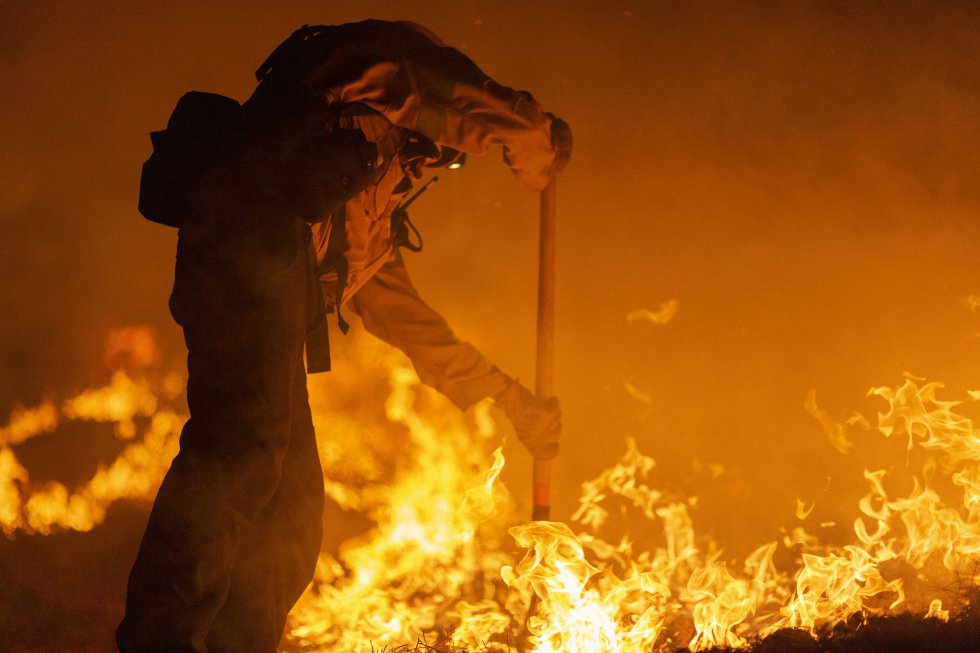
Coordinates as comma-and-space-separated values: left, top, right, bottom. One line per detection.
290, 352, 513, 651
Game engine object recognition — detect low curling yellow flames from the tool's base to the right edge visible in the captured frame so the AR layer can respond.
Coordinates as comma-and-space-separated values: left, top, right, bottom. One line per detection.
502, 379, 980, 652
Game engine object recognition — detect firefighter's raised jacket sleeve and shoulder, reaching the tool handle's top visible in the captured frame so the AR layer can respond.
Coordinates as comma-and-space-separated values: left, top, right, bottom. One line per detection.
284, 20, 556, 190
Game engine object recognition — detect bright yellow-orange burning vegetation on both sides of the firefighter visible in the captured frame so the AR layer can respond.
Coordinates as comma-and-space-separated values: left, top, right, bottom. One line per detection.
0, 328, 980, 653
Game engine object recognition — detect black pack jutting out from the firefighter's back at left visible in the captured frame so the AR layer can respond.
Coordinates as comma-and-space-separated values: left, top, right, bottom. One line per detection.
138, 91, 243, 227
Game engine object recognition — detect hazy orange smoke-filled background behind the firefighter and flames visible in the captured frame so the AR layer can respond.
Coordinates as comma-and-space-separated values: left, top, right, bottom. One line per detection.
0, 0, 980, 552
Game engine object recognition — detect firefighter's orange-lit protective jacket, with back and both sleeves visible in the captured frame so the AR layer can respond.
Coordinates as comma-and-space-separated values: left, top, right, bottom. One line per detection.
258, 20, 557, 408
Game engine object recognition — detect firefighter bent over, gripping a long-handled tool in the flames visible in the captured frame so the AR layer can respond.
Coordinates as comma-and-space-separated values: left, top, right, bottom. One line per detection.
116, 20, 571, 653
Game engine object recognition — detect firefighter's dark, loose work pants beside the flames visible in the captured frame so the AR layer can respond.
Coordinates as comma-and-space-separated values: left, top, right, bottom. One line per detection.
116, 216, 323, 653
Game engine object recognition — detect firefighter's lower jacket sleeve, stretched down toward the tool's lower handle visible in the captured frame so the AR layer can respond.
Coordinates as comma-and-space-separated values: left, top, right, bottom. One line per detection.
351, 255, 513, 410
